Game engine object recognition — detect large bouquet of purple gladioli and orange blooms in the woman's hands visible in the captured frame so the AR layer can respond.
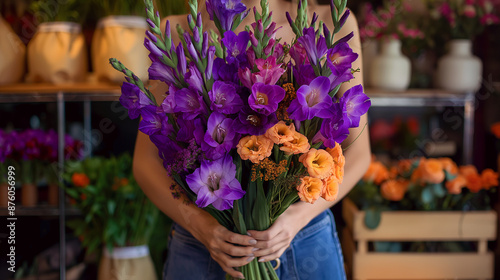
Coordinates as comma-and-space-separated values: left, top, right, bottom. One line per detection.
110, 0, 370, 279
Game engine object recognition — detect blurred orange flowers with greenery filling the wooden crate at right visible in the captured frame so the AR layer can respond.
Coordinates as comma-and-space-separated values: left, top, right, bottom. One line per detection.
349, 158, 498, 228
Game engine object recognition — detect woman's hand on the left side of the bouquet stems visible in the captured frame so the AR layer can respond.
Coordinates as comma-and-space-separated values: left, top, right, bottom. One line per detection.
193, 218, 257, 279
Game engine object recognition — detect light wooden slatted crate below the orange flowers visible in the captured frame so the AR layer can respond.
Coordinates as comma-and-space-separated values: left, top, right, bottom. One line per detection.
342, 199, 497, 280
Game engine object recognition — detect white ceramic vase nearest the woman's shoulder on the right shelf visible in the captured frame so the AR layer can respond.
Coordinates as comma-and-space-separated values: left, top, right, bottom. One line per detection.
370, 39, 411, 91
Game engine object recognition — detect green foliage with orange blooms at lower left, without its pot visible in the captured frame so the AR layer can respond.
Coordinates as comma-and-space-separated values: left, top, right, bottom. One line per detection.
63, 154, 158, 252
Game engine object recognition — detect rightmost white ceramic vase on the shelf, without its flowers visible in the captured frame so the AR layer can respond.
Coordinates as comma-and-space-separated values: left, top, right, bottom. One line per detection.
436, 40, 483, 92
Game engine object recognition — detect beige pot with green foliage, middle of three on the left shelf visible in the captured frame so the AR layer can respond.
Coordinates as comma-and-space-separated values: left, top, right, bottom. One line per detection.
28, 0, 88, 84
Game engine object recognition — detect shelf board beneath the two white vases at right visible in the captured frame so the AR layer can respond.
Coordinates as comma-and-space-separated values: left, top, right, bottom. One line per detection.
365, 88, 474, 107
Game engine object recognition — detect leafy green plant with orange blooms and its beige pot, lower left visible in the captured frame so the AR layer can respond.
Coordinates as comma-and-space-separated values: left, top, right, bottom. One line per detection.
64, 154, 158, 280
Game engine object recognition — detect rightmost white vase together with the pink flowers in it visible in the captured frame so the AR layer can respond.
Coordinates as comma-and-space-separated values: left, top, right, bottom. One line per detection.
429, 0, 500, 92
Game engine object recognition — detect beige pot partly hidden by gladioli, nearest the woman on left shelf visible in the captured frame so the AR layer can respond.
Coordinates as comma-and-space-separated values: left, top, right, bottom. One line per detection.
91, 16, 151, 83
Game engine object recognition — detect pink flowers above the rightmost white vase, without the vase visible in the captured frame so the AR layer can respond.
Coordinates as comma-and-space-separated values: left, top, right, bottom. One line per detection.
428, 0, 500, 40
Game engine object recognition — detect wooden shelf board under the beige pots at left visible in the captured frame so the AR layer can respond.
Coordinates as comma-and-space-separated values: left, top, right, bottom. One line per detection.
0, 83, 120, 103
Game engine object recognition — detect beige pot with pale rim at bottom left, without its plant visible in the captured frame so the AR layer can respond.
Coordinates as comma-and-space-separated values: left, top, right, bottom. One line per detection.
97, 245, 157, 280
